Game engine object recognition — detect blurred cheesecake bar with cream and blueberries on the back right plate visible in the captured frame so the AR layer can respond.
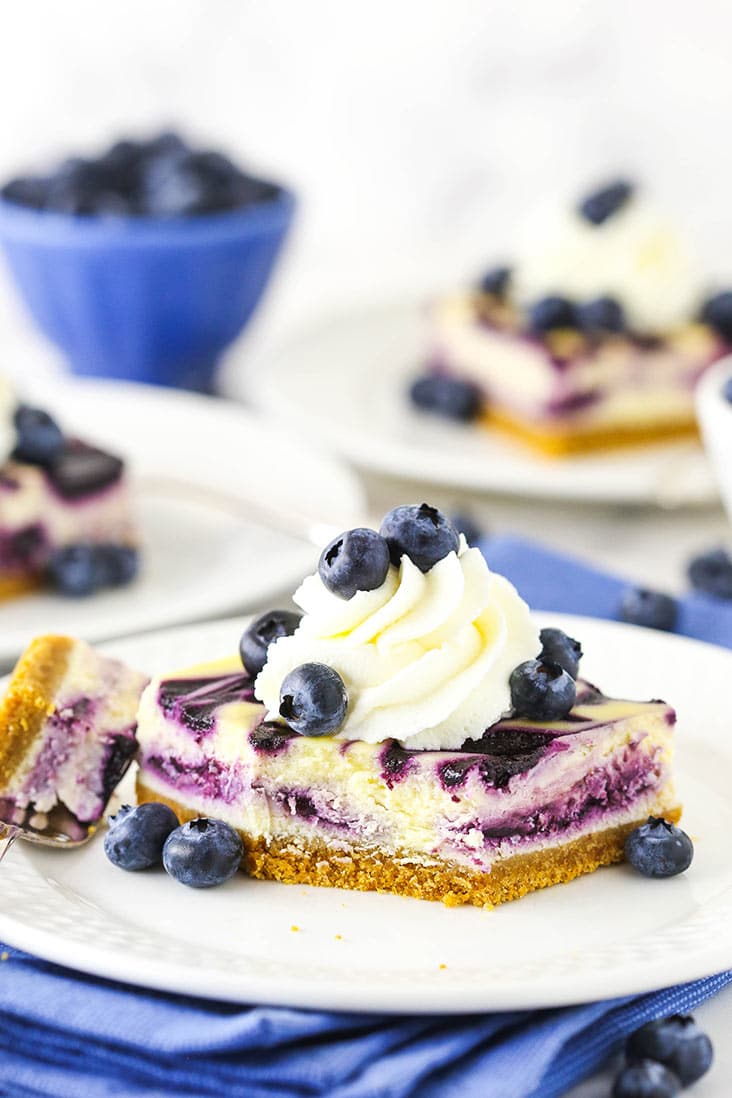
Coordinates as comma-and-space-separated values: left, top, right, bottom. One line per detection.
412, 180, 732, 455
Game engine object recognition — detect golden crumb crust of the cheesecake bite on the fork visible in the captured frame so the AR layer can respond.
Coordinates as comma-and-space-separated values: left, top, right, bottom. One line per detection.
0, 636, 75, 788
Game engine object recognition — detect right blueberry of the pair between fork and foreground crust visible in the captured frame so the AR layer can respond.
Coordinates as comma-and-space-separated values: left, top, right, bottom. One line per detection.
162, 819, 244, 888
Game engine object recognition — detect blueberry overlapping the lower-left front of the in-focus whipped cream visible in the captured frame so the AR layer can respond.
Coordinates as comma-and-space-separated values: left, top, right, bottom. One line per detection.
280, 663, 348, 736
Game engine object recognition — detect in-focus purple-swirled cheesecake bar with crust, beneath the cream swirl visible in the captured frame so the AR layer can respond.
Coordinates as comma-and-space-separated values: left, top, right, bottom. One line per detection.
137, 660, 680, 906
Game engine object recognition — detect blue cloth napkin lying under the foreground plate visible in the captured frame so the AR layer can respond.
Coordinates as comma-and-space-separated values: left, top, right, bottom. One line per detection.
0, 538, 732, 1098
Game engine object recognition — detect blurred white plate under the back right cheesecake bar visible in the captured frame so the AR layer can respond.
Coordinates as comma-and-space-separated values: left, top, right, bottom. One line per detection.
221, 305, 717, 507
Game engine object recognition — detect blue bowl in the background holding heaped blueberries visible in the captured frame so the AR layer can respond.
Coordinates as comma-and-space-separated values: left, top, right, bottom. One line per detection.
0, 190, 295, 391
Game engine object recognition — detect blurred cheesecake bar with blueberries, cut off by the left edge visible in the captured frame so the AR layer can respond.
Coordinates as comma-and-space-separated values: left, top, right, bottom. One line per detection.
0, 382, 138, 598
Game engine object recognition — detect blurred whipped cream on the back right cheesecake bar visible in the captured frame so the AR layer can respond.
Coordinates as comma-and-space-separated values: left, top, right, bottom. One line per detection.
515, 195, 703, 334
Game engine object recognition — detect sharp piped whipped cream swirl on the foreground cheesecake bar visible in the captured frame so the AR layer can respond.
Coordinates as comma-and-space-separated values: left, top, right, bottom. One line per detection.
255, 538, 541, 750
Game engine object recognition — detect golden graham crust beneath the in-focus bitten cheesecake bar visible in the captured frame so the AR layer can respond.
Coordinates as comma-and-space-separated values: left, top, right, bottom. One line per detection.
137, 776, 682, 907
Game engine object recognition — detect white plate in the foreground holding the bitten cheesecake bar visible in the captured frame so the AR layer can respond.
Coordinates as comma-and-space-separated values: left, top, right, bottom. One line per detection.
0, 617, 732, 1012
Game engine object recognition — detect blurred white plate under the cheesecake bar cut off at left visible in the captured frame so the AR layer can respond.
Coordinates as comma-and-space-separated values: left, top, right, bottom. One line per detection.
0, 380, 362, 666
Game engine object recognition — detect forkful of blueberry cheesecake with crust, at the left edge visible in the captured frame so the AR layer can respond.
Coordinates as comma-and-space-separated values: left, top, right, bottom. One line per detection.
0, 636, 147, 839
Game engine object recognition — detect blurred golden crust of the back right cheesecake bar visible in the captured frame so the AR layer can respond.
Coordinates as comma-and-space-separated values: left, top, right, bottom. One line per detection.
481, 407, 699, 458
